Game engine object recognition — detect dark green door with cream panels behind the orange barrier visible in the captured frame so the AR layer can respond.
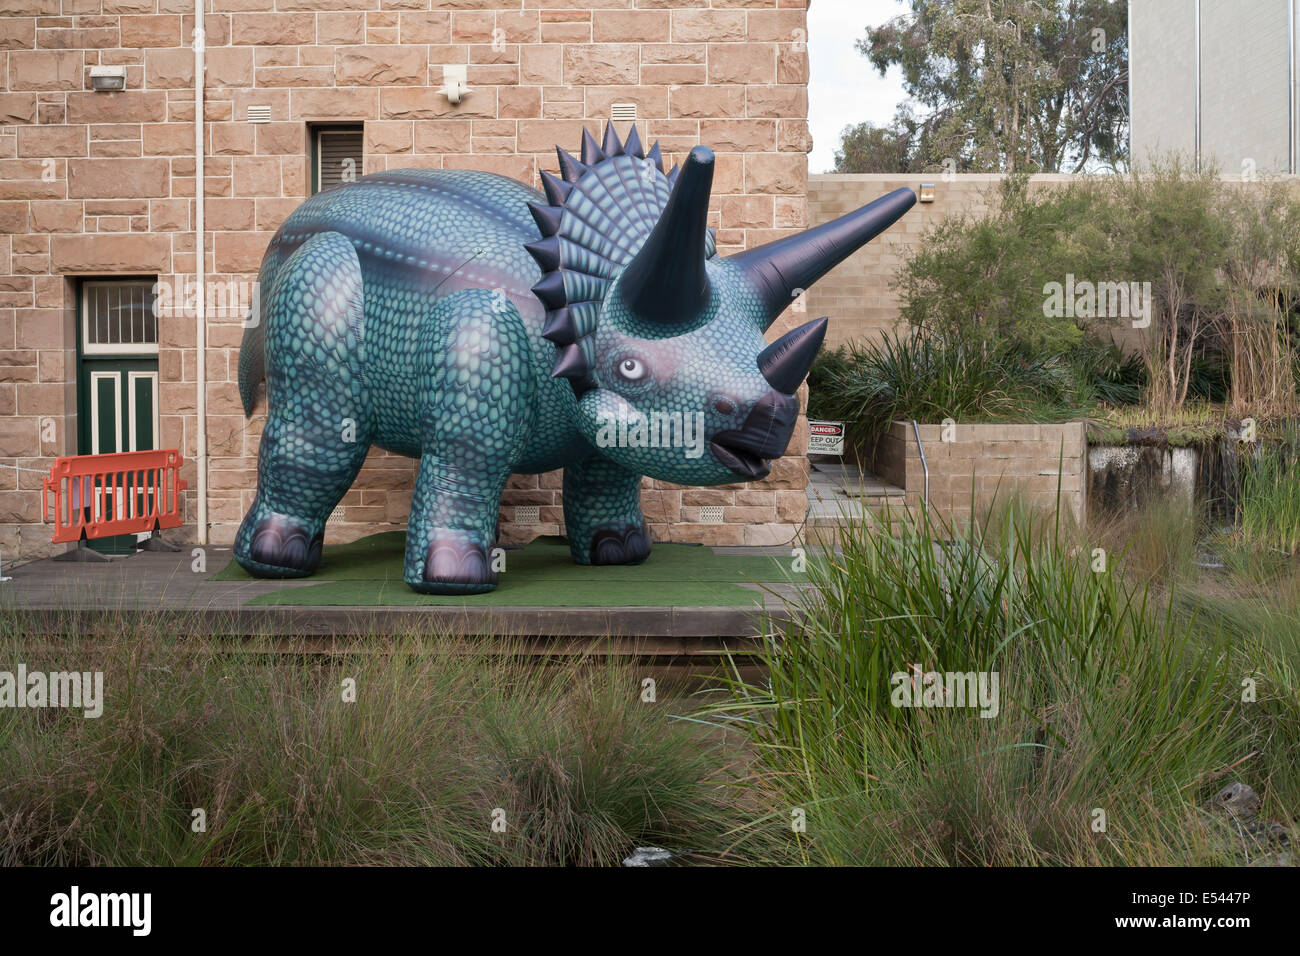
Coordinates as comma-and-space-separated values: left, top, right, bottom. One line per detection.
77, 280, 159, 554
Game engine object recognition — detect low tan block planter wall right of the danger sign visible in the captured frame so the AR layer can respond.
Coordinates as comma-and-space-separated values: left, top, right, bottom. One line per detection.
868, 421, 1088, 524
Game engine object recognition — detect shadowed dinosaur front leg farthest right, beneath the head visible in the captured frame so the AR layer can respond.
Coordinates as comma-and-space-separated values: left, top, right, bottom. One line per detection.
564, 455, 650, 564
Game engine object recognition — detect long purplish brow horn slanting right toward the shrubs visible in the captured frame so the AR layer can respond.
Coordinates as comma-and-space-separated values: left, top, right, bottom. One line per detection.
727, 186, 917, 332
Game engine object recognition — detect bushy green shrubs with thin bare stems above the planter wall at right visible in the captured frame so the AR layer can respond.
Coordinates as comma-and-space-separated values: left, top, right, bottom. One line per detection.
894, 157, 1300, 418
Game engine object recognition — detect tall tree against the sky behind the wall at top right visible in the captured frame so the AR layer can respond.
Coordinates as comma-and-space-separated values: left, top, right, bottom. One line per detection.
863, 0, 1128, 173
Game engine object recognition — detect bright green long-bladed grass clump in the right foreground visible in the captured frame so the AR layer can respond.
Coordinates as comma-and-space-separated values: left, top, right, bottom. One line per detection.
714, 502, 1251, 865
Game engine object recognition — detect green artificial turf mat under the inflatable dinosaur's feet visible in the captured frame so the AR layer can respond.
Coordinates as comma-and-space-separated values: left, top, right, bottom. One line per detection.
212, 531, 805, 607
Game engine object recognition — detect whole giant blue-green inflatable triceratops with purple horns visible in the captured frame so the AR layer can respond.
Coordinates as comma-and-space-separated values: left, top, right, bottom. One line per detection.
235, 124, 915, 593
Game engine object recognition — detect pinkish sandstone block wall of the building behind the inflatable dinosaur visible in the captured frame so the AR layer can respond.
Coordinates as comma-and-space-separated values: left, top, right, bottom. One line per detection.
0, 0, 810, 559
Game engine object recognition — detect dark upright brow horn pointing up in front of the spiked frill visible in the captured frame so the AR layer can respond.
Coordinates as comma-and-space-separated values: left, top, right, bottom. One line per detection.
621, 146, 714, 324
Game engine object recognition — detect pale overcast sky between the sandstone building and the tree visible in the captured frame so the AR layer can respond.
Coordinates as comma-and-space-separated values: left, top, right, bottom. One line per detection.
809, 0, 909, 173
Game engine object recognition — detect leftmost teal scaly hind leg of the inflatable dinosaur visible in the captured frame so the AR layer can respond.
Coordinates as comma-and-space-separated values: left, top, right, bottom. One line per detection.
235, 233, 369, 578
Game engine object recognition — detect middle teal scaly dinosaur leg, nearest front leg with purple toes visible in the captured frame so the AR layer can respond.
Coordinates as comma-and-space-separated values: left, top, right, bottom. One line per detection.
403, 289, 534, 594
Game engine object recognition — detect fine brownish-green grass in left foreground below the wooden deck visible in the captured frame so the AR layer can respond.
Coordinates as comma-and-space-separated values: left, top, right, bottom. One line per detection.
0, 614, 749, 865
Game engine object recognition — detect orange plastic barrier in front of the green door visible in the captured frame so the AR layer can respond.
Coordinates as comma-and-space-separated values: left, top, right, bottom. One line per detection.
40, 449, 187, 542
